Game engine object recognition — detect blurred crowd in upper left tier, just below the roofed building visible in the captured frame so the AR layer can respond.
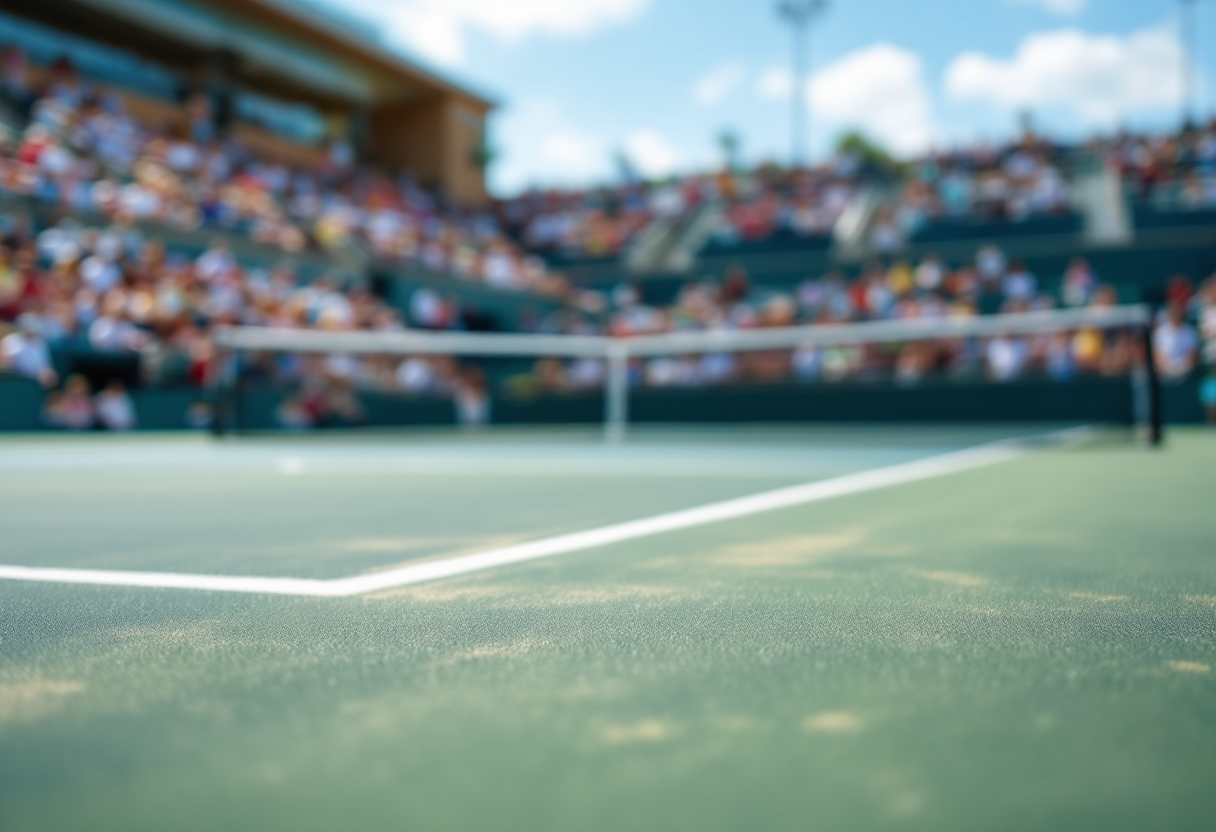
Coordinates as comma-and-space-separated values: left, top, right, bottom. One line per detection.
0, 47, 568, 296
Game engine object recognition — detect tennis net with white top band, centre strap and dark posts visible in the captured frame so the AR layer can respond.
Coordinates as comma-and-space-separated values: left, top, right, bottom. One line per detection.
212, 305, 1160, 440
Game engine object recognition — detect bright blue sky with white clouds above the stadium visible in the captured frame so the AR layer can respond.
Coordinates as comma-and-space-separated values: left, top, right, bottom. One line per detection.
321, 0, 1216, 195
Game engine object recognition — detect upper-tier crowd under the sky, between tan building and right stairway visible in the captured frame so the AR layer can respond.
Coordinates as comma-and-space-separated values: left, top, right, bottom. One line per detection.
500, 135, 1070, 259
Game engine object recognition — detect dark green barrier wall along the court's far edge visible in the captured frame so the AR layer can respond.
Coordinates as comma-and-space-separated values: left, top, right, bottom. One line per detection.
0, 377, 1204, 431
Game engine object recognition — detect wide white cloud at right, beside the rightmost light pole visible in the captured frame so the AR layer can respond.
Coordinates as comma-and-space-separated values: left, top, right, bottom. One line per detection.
946, 29, 1182, 128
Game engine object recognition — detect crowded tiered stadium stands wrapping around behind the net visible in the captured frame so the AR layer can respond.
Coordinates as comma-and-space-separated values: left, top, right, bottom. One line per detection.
0, 2, 1216, 427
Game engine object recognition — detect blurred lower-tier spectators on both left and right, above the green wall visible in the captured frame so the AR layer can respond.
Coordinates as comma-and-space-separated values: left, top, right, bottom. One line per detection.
0, 211, 1216, 427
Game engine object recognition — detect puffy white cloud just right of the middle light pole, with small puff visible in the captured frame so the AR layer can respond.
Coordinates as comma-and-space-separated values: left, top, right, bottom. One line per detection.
756, 44, 936, 154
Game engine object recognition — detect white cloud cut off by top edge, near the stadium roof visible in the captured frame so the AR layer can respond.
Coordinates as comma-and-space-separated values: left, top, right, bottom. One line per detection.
330, 0, 649, 64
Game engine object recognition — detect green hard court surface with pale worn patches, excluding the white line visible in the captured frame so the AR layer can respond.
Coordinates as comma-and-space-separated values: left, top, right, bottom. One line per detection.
0, 428, 1216, 832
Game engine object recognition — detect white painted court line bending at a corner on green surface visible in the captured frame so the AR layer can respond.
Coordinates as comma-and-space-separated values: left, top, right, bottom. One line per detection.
0, 428, 1090, 598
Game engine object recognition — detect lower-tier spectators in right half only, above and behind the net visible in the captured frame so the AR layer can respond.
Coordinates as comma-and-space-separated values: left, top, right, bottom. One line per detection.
522, 246, 1216, 390
